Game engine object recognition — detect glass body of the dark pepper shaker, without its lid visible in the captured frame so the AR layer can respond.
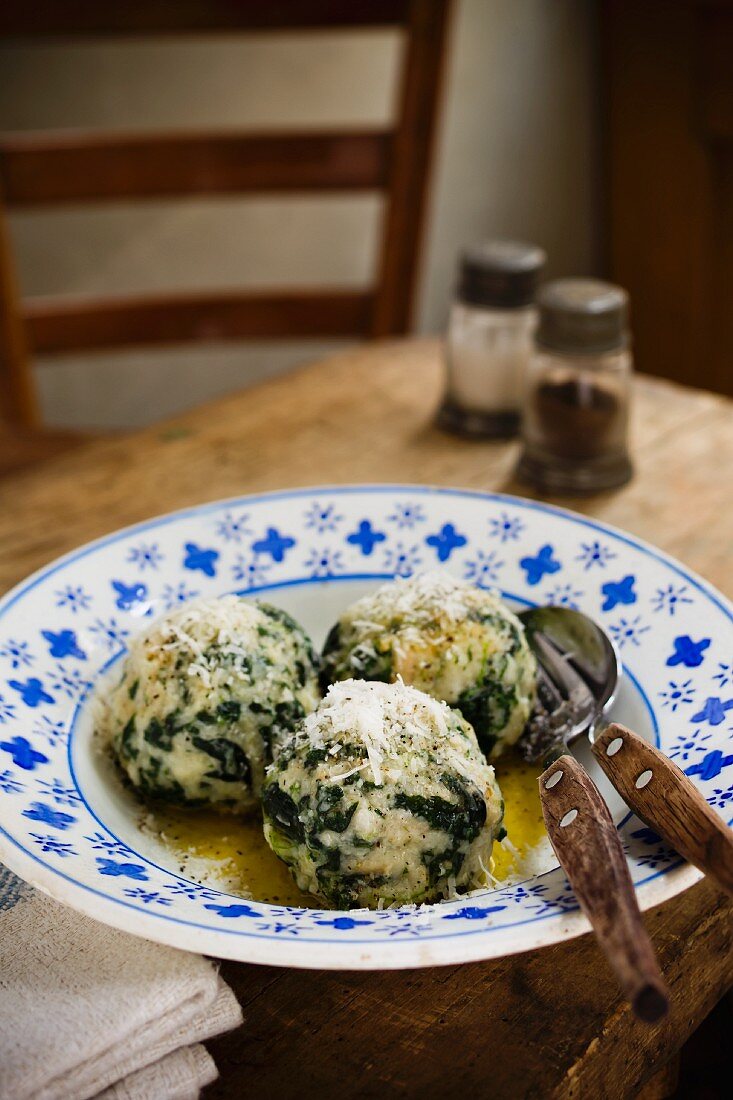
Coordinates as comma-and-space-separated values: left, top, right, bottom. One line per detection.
517, 348, 633, 493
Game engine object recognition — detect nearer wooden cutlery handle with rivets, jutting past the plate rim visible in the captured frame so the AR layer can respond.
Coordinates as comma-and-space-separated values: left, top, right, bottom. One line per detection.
539, 756, 669, 1023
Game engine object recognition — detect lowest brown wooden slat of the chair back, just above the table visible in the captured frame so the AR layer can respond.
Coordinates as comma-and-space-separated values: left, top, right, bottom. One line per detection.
23, 289, 374, 353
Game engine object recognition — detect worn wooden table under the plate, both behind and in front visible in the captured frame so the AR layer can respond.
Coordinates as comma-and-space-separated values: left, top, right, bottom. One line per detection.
0, 341, 733, 1100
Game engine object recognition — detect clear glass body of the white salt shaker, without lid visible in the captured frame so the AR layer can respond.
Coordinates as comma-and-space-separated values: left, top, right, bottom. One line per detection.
439, 300, 537, 438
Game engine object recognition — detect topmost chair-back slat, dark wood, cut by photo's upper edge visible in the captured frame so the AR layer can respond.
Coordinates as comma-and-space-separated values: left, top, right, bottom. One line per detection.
0, 0, 409, 37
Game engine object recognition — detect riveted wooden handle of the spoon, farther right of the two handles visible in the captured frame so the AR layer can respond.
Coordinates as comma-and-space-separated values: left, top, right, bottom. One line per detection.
593, 722, 733, 894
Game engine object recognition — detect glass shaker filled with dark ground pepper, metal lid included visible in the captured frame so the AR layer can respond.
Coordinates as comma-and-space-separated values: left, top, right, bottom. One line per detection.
517, 278, 632, 493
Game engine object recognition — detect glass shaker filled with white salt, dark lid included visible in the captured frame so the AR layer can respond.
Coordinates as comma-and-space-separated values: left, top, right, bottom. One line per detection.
438, 241, 546, 438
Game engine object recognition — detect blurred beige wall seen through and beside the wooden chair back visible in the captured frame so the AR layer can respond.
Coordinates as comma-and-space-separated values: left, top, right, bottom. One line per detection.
0, 0, 595, 427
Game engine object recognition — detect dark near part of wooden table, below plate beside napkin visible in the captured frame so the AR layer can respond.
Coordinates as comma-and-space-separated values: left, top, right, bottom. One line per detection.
206, 882, 733, 1100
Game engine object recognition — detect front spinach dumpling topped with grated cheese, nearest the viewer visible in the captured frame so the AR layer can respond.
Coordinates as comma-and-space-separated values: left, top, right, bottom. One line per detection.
262, 680, 504, 909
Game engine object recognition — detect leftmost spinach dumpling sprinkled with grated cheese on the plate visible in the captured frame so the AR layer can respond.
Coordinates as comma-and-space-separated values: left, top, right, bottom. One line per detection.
107, 595, 319, 811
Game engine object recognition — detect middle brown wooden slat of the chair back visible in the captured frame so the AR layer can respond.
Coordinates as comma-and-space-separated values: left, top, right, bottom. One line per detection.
0, 130, 391, 207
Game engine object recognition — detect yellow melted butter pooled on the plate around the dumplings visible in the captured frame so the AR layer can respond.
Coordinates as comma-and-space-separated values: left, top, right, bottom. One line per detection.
152, 752, 545, 908
